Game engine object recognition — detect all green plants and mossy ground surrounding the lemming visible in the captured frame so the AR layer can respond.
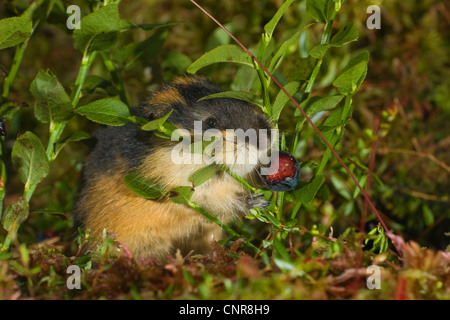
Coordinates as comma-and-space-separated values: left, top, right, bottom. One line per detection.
0, 0, 450, 299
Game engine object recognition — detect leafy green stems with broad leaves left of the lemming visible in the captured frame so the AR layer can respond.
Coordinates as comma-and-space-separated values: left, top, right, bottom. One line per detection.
0, 1, 173, 255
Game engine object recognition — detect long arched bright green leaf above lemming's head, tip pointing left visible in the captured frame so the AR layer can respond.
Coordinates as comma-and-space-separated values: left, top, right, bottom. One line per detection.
187, 44, 253, 74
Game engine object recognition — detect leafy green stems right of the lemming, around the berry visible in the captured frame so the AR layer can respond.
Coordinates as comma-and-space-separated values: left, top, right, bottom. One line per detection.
188, 1, 368, 260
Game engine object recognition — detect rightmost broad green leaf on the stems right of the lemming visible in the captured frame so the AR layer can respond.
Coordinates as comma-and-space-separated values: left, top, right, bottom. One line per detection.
333, 51, 369, 95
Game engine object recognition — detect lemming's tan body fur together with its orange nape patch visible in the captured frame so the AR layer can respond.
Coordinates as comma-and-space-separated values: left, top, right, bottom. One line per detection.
75, 78, 270, 259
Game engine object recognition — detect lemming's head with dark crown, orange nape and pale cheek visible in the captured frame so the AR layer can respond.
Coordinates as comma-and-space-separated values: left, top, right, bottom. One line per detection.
141, 77, 272, 175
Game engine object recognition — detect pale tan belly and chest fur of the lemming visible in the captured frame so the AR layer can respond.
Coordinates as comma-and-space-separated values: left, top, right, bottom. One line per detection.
84, 151, 246, 259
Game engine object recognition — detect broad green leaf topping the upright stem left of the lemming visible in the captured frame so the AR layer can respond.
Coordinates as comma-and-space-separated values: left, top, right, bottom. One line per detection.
73, 4, 121, 53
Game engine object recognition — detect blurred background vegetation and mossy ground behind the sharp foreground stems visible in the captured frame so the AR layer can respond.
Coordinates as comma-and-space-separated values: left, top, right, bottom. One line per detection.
0, 0, 450, 299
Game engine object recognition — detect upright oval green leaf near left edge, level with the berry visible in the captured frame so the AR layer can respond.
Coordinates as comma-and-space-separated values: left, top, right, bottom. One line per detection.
11, 131, 50, 189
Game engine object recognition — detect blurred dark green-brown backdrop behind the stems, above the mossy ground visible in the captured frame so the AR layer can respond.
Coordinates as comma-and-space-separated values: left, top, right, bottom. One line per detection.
0, 0, 450, 249
